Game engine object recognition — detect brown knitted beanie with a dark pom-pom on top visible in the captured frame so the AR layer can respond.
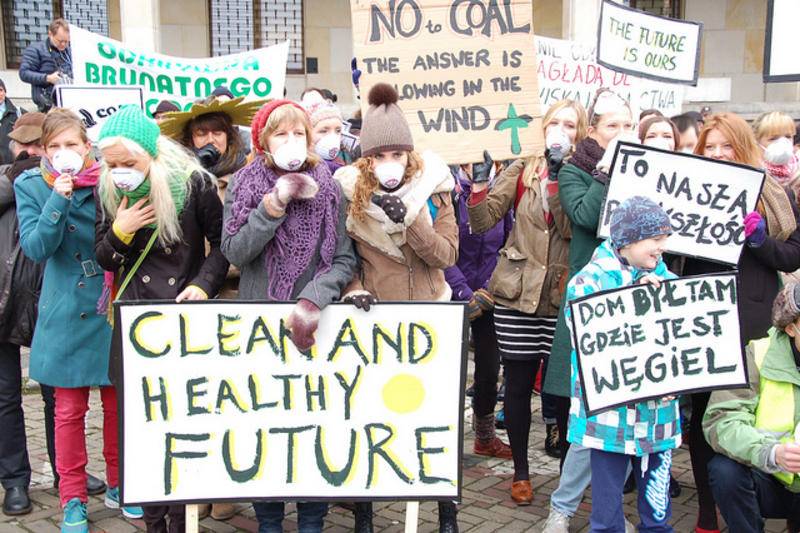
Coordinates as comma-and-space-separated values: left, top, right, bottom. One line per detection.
361, 83, 414, 157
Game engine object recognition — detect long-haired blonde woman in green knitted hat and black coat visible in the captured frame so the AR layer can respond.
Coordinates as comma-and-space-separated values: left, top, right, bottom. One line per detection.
95, 106, 228, 533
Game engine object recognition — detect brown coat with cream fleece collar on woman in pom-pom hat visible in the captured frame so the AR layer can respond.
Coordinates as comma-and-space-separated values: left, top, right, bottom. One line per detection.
334, 153, 458, 301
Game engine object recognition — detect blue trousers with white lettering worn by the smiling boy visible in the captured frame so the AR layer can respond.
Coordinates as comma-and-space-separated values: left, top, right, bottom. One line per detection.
589, 450, 673, 533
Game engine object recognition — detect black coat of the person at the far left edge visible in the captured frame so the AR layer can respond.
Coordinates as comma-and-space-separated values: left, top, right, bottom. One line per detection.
0, 154, 44, 346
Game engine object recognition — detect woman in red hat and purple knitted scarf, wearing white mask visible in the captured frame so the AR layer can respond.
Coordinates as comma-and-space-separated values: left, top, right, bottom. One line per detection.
222, 100, 357, 533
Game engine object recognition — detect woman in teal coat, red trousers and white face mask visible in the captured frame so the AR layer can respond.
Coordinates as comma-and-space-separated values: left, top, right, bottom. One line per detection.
14, 108, 142, 533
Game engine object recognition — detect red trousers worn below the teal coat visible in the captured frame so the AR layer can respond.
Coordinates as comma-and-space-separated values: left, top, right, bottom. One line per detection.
55, 387, 119, 507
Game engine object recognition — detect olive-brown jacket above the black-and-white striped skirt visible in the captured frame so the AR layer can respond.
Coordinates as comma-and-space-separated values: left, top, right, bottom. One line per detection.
468, 159, 570, 317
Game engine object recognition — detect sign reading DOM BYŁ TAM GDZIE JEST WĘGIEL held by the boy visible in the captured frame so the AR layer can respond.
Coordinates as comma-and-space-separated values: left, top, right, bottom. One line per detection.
570, 272, 748, 415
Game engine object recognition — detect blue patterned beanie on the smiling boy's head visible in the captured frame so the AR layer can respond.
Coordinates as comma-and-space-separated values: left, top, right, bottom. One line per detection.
610, 196, 672, 250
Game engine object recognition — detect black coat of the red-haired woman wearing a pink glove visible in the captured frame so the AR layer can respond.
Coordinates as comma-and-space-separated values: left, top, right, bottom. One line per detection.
683, 206, 800, 344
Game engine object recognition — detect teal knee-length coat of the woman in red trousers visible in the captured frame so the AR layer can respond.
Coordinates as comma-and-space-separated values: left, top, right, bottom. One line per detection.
14, 169, 111, 388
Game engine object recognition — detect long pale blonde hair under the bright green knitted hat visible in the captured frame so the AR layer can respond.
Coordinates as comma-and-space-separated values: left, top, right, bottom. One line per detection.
98, 135, 209, 246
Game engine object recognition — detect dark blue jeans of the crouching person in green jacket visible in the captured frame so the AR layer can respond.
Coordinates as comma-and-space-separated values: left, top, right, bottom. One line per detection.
708, 454, 800, 533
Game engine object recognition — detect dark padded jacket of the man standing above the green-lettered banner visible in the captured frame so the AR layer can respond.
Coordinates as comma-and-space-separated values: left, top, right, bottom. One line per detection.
19, 37, 72, 112
